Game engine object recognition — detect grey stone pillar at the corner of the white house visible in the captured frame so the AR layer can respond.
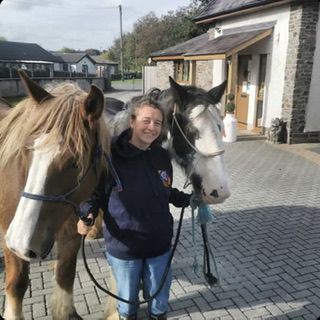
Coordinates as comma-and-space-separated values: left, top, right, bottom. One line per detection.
282, 0, 320, 143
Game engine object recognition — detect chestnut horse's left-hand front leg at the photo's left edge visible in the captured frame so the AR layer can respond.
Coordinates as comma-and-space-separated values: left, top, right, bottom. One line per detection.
3, 247, 29, 320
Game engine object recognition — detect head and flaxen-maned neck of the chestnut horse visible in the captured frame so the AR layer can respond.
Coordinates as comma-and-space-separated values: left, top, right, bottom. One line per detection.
0, 72, 109, 260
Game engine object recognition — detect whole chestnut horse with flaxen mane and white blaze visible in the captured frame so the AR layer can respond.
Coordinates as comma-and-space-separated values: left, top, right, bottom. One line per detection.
0, 71, 109, 320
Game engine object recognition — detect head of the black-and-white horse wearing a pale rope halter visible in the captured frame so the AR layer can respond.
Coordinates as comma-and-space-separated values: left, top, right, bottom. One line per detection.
158, 78, 230, 204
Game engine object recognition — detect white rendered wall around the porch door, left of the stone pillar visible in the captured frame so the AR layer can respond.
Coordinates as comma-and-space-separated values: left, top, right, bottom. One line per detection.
220, 5, 290, 127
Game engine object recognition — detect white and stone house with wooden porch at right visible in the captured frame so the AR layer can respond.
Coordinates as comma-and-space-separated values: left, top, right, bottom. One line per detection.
151, 0, 320, 143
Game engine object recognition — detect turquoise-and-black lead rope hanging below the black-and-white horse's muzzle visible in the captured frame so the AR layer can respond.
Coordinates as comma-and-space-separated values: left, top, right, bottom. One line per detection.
191, 202, 220, 287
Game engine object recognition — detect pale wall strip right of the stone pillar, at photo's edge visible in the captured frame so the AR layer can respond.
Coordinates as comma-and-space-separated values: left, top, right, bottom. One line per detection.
305, 4, 320, 132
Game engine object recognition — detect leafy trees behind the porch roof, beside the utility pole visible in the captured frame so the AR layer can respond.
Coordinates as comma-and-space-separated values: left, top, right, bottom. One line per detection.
107, 0, 210, 71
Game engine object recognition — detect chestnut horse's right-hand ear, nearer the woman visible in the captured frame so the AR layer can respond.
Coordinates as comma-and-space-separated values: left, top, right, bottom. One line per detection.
81, 85, 104, 126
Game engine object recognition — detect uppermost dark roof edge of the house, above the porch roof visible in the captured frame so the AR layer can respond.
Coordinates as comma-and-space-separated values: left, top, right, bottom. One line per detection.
193, 0, 293, 23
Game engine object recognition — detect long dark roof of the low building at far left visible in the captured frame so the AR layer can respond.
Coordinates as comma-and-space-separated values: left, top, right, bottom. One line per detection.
0, 41, 59, 63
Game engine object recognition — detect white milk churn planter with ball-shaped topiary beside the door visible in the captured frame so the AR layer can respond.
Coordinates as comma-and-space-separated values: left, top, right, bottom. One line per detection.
223, 93, 237, 142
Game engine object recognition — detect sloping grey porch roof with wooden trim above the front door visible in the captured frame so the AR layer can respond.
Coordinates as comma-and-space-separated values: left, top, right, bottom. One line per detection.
151, 22, 275, 60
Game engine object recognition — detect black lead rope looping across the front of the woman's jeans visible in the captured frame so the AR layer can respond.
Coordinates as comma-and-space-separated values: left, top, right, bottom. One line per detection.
81, 206, 185, 305
